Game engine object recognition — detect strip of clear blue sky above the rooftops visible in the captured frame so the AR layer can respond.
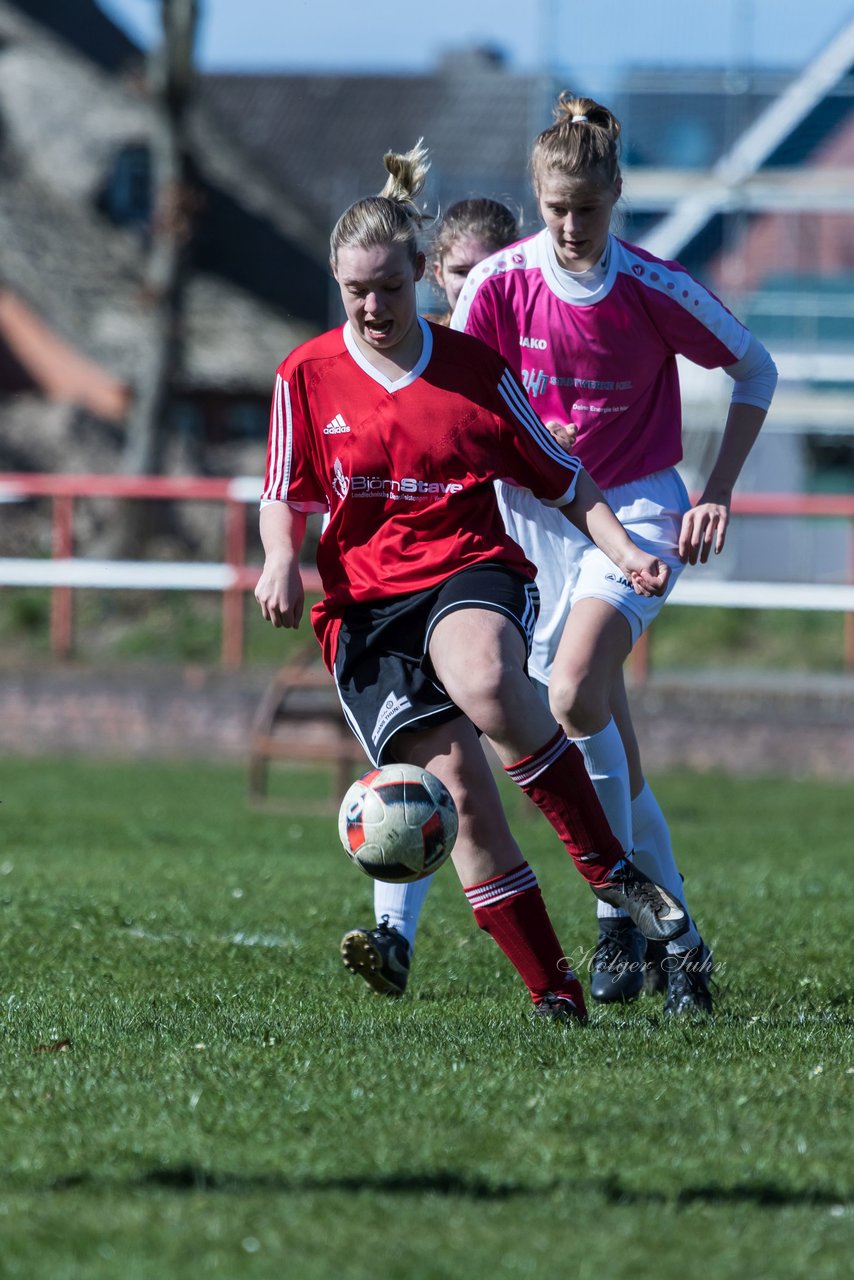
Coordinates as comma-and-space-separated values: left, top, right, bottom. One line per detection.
99, 0, 854, 79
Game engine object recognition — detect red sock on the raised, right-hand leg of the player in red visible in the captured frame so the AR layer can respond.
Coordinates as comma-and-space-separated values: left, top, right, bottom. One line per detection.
504, 728, 626, 886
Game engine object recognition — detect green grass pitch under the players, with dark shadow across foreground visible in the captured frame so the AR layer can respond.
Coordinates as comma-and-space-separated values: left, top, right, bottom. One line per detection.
0, 760, 854, 1280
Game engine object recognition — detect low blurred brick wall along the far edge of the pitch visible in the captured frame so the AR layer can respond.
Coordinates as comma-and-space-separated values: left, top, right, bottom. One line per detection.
0, 666, 854, 778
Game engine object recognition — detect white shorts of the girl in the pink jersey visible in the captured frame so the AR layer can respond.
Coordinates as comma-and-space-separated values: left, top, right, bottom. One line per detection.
495, 467, 691, 684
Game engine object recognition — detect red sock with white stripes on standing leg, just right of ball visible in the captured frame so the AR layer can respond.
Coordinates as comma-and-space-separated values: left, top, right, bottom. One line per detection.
466, 863, 586, 1016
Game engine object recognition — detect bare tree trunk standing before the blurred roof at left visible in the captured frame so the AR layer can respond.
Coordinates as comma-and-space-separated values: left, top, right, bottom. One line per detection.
123, 0, 198, 475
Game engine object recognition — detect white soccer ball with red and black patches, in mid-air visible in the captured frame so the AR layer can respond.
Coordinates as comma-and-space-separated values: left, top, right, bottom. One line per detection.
338, 764, 458, 884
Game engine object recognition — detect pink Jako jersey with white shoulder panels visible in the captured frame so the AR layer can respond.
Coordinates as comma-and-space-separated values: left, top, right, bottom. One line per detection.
451, 230, 750, 489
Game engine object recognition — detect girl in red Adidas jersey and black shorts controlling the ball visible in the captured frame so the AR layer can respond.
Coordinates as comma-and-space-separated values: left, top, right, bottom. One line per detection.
255, 145, 686, 1020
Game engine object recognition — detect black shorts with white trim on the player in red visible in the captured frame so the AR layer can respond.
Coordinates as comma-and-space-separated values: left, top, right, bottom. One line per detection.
333, 564, 539, 765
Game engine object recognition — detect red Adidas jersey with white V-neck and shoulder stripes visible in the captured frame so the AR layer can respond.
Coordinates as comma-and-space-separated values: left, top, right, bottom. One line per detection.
262, 320, 580, 668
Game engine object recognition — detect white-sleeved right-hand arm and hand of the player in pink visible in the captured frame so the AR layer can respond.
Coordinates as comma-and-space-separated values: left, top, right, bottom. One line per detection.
679, 337, 777, 564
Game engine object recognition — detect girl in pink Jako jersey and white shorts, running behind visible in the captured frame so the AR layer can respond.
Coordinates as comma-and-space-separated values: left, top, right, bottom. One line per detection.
452, 93, 776, 1014
